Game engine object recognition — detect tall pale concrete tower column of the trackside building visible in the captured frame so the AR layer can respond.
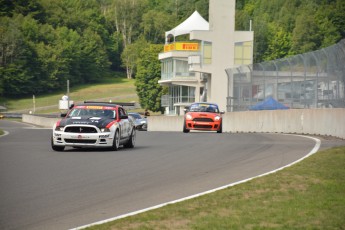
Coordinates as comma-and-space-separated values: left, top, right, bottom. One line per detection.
190, 0, 254, 111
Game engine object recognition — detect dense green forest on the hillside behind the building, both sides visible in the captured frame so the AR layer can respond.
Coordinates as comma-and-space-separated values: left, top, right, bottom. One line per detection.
0, 0, 345, 101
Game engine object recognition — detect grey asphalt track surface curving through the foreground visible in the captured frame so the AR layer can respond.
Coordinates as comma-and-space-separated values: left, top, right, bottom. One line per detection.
0, 120, 338, 230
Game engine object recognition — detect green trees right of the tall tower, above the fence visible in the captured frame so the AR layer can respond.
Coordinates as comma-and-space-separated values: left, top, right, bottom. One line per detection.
236, 0, 345, 62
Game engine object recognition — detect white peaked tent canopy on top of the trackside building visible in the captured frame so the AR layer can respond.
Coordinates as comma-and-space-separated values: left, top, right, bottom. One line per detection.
165, 11, 209, 41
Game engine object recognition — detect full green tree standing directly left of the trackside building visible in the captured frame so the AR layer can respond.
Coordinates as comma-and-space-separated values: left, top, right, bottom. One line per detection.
135, 44, 165, 112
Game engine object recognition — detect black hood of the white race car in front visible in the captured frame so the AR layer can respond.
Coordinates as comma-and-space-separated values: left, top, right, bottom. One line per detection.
60, 117, 114, 128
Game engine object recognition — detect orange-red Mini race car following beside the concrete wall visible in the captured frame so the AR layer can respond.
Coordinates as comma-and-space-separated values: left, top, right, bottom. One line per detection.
183, 102, 224, 133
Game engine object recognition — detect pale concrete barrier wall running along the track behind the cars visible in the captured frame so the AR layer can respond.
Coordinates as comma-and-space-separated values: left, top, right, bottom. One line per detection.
23, 108, 345, 139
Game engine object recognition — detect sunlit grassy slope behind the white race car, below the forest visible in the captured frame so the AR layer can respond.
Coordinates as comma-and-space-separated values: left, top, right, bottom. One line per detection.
0, 77, 139, 113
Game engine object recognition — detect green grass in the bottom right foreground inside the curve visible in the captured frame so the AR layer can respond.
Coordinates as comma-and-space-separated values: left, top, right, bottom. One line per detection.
88, 147, 345, 230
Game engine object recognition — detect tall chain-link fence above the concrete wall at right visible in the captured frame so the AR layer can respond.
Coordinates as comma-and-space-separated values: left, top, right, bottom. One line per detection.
226, 39, 345, 112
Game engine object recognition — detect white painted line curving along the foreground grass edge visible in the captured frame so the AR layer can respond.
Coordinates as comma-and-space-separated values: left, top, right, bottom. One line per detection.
70, 134, 321, 230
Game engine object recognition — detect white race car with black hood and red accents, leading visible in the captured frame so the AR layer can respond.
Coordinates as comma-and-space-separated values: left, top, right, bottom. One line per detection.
51, 102, 136, 151
